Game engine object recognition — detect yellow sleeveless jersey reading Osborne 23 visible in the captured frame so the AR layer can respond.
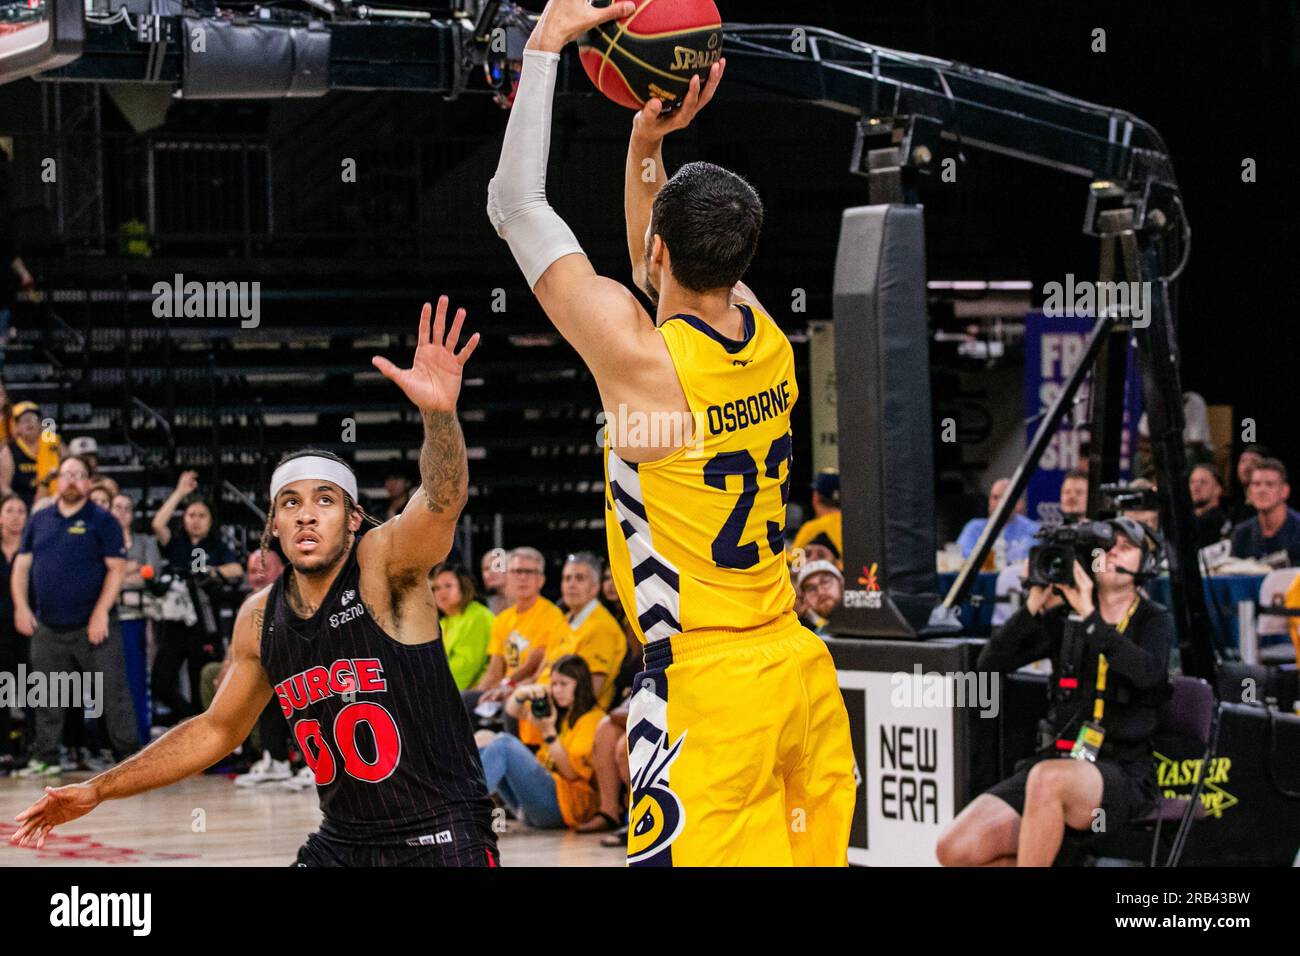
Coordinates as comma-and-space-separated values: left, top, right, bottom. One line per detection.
605, 304, 798, 650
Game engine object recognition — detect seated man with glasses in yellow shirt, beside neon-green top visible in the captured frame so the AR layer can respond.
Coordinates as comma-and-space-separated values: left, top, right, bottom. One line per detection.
464, 548, 568, 710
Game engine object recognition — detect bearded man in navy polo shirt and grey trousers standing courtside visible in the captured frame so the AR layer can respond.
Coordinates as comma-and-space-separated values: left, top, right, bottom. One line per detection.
13, 457, 140, 777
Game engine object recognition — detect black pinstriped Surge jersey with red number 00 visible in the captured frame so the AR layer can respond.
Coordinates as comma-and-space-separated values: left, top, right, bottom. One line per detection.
261, 545, 494, 855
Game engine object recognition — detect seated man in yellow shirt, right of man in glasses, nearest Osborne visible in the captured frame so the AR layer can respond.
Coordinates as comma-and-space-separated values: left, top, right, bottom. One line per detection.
519, 551, 628, 745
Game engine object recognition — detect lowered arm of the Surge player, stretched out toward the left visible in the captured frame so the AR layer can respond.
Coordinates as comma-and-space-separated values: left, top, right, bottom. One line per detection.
9, 588, 270, 848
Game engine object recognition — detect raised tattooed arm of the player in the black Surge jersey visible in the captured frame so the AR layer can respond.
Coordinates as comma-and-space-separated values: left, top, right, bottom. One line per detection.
361, 295, 478, 581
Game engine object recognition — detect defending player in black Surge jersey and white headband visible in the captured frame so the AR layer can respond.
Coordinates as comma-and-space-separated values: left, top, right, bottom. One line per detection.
10, 297, 497, 866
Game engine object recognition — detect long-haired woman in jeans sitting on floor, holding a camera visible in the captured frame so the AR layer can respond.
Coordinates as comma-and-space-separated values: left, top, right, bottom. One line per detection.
477, 654, 605, 829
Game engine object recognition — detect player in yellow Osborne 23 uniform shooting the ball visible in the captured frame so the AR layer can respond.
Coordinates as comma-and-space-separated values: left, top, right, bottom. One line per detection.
488, 0, 854, 866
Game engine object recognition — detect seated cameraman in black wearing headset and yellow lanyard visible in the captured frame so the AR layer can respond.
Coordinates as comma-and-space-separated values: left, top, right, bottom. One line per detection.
936, 518, 1174, 866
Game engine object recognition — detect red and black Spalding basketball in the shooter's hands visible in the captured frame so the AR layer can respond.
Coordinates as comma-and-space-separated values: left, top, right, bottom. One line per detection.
579, 0, 723, 112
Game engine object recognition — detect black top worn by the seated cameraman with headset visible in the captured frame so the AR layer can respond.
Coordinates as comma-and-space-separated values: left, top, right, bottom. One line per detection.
978, 598, 1175, 761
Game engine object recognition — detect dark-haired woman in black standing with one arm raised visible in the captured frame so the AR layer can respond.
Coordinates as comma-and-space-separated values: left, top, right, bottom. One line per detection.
151, 471, 243, 722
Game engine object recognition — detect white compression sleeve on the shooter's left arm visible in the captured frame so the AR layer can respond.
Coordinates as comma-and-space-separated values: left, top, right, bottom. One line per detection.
488, 49, 582, 289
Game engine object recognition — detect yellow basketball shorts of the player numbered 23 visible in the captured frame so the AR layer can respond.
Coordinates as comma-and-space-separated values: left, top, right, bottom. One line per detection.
628, 617, 855, 866
